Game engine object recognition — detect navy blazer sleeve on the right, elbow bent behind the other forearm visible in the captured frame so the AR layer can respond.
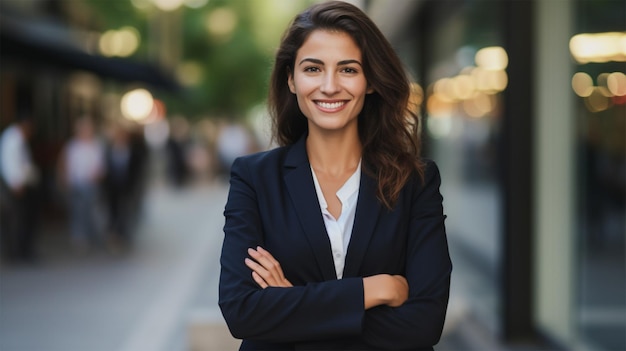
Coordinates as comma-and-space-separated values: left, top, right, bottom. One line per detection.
362, 161, 452, 350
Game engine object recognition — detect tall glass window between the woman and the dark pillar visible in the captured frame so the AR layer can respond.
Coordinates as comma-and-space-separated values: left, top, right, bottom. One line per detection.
416, 1, 508, 332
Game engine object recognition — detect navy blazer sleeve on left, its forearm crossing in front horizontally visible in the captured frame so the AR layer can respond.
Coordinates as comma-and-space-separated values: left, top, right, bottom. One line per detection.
219, 159, 364, 343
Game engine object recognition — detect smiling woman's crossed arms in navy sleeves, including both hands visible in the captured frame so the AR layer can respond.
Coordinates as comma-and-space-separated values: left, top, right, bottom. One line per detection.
219, 157, 452, 350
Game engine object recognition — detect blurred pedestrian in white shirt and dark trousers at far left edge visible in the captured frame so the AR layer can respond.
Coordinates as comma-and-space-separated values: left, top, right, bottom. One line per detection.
0, 112, 39, 262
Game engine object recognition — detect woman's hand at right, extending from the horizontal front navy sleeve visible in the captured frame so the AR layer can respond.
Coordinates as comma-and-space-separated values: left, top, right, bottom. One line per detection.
363, 274, 409, 309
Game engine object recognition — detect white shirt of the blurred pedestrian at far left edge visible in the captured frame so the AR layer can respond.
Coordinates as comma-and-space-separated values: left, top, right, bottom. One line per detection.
0, 125, 38, 189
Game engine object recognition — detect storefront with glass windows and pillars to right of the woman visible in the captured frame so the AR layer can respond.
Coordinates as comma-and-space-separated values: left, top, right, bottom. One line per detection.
366, 0, 626, 350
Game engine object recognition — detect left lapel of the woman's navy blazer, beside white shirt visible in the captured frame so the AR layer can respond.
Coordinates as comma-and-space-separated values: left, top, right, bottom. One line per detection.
284, 135, 337, 280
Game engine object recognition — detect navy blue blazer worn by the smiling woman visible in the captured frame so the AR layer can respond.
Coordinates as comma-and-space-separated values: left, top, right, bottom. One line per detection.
219, 137, 452, 350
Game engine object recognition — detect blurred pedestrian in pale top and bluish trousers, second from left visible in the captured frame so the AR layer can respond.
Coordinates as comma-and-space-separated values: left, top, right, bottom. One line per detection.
60, 116, 105, 252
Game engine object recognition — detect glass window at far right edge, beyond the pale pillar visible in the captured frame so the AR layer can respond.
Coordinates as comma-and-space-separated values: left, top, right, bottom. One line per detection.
570, 1, 626, 350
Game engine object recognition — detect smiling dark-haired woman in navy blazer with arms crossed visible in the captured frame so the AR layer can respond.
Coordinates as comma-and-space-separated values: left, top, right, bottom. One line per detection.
219, 2, 452, 350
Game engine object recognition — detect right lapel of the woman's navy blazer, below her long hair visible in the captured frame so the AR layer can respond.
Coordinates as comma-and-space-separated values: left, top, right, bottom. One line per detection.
343, 171, 381, 277
